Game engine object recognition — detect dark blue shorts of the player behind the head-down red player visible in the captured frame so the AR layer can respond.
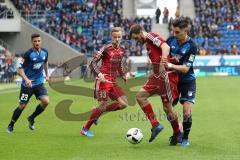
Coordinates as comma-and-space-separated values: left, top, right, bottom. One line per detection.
178, 80, 196, 104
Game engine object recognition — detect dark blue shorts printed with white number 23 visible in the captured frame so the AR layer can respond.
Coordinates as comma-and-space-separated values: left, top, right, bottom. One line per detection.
19, 83, 48, 104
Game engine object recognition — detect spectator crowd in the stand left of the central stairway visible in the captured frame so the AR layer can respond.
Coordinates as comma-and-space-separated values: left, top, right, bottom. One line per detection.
12, 0, 152, 56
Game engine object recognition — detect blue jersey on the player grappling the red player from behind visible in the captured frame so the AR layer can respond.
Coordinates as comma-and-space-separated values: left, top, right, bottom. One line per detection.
167, 37, 197, 82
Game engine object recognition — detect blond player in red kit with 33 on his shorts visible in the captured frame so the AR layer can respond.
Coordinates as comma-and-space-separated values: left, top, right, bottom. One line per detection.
81, 27, 128, 137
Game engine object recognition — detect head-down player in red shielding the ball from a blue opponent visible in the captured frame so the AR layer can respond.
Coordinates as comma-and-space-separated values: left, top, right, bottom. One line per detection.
130, 24, 181, 143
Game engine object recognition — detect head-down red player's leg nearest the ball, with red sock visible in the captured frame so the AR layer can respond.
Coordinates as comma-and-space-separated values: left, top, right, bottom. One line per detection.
136, 88, 164, 142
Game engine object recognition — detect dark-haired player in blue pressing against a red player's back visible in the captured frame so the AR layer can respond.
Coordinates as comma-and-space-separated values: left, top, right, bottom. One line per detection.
167, 17, 197, 146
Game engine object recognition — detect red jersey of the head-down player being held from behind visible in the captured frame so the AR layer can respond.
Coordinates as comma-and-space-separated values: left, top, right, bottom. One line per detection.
146, 32, 168, 74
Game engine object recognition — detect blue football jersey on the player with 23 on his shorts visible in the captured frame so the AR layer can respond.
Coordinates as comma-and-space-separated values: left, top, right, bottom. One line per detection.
19, 48, 48, 86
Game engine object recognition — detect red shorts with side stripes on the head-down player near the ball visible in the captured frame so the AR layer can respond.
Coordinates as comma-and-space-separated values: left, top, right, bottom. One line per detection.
143, 72, 178, 103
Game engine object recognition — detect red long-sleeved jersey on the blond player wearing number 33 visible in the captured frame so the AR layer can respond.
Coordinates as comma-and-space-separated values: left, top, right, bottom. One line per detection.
90, 44, 125, 81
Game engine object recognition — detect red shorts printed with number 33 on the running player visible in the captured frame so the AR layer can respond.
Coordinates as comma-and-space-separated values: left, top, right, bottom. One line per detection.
94, 80, 124, 101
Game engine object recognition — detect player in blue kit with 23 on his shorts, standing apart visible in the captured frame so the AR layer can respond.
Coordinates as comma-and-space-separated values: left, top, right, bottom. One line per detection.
7, 34, 49, 133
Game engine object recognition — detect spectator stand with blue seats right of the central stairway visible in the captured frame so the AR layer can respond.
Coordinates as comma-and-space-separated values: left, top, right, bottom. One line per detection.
170, 0, 240, 55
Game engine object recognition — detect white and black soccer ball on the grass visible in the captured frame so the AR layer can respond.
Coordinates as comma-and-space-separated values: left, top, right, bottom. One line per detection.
126, 128, 143, 144
